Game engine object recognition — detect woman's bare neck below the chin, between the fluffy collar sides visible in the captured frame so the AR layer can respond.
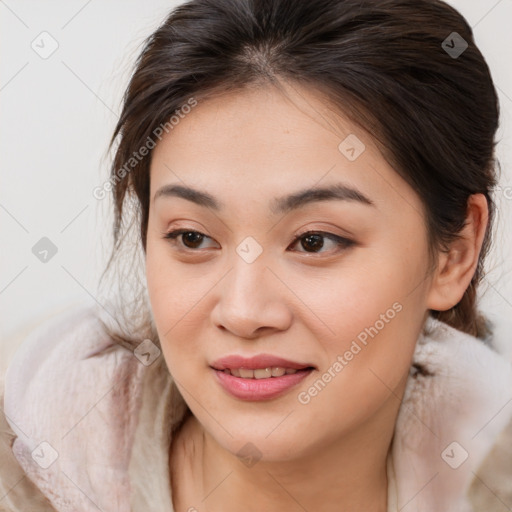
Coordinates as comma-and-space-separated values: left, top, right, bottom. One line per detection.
170, 396, 399, 512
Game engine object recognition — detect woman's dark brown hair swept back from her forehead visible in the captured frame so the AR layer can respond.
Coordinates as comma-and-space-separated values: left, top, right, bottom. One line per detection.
104, 0, 499, 344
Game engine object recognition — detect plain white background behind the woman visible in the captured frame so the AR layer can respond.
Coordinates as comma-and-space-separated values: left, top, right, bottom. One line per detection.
0, 0, 512, 367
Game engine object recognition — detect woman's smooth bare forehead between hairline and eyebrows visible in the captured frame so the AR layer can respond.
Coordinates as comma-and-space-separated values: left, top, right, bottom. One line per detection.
151, 82, 419, 218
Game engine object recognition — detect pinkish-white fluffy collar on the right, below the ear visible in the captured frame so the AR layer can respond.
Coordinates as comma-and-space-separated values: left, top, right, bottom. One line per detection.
393, 318, 512, 512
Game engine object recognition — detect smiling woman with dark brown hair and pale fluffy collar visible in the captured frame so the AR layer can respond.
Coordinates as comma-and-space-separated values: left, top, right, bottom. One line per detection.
0, 0, 512, 512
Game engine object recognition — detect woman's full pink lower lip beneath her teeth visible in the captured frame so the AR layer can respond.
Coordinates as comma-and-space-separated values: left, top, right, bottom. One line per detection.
213, 369, 313, 402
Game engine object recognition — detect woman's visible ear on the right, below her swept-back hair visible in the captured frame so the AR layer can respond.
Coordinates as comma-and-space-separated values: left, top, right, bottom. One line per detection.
427, 194, 489, 311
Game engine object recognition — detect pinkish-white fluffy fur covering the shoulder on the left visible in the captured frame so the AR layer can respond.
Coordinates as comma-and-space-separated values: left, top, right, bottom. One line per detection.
0, 307, 144, 510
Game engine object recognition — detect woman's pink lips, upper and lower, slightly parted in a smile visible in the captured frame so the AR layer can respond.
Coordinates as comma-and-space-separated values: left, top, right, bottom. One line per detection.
211, 354, 315, 402
